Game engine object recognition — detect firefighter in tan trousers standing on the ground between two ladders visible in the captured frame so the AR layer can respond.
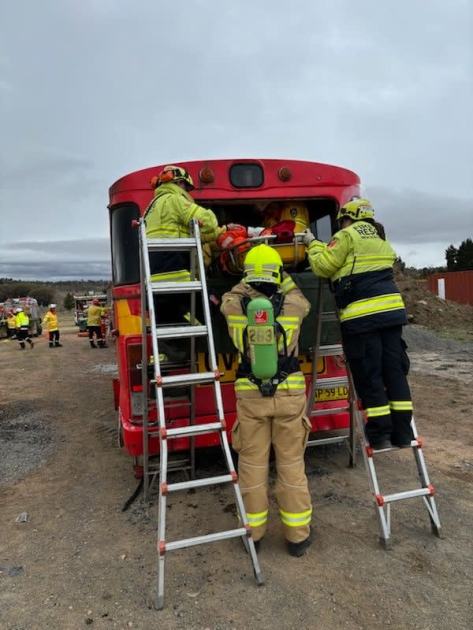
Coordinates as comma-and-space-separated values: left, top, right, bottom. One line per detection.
221, 245, 312, 556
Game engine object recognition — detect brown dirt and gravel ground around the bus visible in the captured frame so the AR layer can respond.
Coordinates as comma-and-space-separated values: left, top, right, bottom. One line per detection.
0, 329, 473, 630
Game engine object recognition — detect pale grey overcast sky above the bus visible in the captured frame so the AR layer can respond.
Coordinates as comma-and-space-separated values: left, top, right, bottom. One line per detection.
0, 0, 473, 278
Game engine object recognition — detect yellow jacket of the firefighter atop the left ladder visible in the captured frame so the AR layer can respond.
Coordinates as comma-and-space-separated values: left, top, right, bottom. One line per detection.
145, 182, 221, 282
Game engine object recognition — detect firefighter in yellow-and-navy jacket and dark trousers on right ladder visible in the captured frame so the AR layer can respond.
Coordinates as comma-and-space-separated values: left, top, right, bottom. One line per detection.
304, 197, 413, 449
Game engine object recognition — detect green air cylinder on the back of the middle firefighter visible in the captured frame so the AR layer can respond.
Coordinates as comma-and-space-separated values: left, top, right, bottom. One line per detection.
246, 297, 278, 380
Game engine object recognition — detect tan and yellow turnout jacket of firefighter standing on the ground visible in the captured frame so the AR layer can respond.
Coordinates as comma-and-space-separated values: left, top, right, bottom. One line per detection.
221, 274, 310, 398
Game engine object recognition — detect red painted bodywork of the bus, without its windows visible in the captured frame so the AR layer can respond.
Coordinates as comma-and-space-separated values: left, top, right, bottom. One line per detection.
109, 158, 360, 457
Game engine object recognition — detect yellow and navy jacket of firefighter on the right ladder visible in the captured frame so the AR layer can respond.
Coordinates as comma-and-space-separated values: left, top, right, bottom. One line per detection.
308, 221, 407, 334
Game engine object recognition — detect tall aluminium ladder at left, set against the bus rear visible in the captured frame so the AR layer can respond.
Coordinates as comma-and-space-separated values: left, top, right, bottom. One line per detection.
138, 220, 264, 610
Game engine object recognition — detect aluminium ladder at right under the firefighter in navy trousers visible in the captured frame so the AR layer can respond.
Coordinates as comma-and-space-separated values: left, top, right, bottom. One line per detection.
308, 281, 441, 549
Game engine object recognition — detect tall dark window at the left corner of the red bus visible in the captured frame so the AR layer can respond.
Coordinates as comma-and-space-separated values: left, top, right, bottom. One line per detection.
110, 203, 140, 284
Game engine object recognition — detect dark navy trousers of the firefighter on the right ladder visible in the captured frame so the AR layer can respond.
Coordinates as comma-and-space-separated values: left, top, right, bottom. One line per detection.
343, 326, 413, 445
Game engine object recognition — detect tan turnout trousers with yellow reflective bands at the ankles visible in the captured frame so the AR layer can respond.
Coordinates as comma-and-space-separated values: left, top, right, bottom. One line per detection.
232, 392, 312, 543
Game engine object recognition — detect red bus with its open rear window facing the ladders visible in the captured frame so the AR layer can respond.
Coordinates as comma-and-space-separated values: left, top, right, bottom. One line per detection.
109, 159, 360, 474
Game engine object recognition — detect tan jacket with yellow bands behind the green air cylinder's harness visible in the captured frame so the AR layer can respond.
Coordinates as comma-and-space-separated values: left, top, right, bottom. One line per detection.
221, 274, 310, 398
